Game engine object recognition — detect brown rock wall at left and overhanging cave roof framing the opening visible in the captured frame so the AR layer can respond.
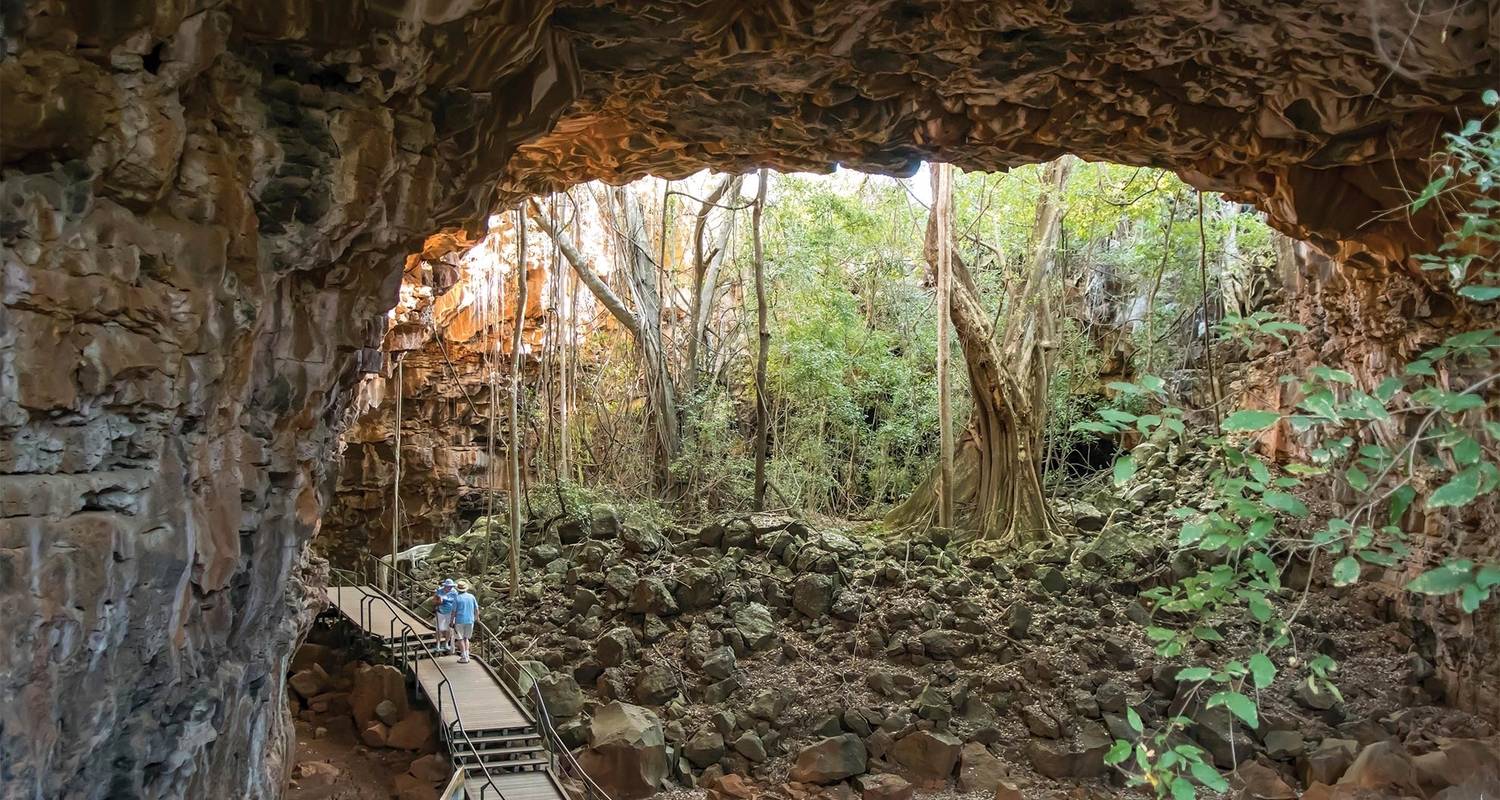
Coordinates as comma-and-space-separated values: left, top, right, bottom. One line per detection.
0, 0, 1500, 798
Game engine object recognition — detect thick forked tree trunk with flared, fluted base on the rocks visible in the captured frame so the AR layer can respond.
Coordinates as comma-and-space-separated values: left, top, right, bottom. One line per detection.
887, 158, 1073, 545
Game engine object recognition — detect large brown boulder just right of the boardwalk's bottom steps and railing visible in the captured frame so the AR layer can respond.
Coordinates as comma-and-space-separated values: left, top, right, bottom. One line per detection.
579, 702, 668, 800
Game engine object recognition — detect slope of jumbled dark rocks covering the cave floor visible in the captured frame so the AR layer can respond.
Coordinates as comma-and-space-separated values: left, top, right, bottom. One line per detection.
390, 435, 1497, 800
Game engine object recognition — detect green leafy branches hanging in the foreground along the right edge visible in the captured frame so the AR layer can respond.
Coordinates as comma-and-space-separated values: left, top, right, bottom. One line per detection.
1085, 104, 1500, 798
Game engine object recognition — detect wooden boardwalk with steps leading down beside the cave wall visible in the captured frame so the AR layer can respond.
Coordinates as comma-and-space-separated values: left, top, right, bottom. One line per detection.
329, 585, 564, 800
